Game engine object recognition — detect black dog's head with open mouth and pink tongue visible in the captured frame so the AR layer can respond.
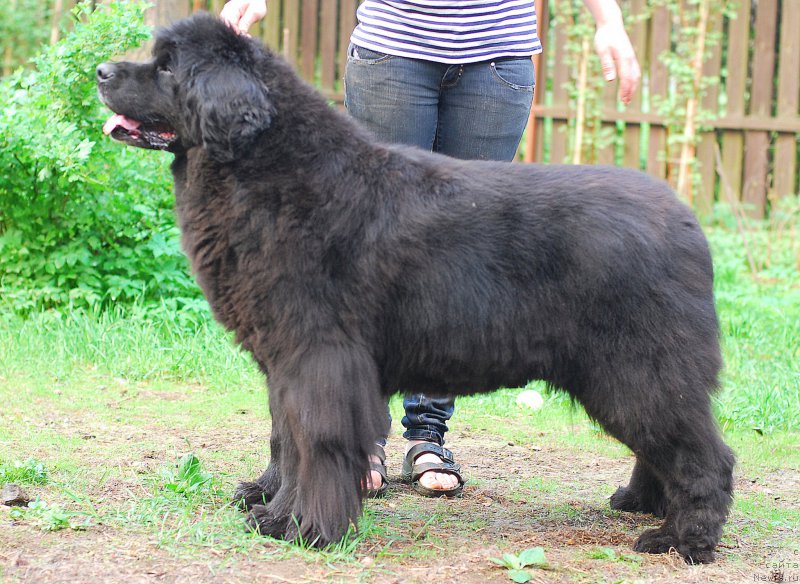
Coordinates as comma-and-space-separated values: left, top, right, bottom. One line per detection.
97, 14, 274, 162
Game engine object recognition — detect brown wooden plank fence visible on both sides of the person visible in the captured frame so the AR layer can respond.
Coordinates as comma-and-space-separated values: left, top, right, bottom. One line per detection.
9, 0, 800, 216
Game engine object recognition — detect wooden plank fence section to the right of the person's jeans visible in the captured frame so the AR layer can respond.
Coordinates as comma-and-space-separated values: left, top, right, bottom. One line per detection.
526, 0, 800, 216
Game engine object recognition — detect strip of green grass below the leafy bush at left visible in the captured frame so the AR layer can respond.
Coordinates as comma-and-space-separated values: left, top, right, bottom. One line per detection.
0, 307, 264, 390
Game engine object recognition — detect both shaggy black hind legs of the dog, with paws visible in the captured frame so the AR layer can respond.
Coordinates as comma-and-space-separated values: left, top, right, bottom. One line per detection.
582, 358, 734, 563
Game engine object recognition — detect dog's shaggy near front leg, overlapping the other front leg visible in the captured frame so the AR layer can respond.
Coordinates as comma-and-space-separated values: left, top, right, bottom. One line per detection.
244, 344, 388, 547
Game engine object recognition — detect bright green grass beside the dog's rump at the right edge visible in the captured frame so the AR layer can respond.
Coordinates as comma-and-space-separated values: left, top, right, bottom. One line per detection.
710, 229, 800, 432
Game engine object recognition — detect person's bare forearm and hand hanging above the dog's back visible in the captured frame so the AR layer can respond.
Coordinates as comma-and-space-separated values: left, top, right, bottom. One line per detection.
583, 0, 642, 104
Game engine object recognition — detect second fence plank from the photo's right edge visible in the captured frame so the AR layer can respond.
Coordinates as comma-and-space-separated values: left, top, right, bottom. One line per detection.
742, 0, 778, 217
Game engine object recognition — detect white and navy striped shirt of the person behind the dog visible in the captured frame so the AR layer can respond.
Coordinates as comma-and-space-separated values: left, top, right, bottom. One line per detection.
350, 0, 542, 63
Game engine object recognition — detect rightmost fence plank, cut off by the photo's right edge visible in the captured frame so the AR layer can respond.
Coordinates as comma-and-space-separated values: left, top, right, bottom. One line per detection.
774, 0, 800, 197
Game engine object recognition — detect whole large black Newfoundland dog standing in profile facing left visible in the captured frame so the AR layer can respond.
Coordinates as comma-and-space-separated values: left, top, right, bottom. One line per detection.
97, 14, 734, 562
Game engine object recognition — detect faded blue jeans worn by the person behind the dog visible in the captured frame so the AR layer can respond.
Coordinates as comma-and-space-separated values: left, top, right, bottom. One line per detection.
344, 45, 534, 445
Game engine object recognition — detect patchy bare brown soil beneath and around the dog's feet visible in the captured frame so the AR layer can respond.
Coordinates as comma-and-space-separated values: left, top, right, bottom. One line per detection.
0, 428, 800, 584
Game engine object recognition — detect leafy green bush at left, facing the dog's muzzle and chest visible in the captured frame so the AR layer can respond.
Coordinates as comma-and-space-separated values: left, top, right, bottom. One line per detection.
0, 2, 198, 313
